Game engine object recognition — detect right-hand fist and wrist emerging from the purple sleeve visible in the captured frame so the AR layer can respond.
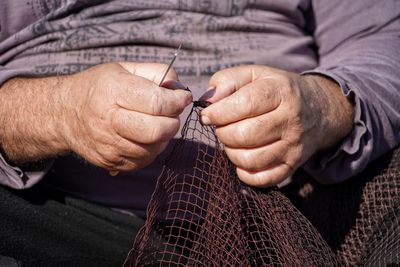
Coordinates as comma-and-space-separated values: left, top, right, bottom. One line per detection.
201, 66, 353, 187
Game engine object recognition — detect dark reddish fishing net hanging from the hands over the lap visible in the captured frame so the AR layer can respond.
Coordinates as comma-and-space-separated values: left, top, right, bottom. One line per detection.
124, 104, 400, 266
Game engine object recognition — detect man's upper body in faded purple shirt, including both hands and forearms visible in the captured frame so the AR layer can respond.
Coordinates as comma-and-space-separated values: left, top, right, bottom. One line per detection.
0, 0, 400, 266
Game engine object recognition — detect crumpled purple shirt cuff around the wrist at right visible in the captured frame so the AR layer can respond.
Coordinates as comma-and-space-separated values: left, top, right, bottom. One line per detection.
302, 69, 368, 184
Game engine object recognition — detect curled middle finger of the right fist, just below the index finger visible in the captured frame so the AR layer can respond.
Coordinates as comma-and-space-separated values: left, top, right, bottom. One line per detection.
216, 108, 287, 148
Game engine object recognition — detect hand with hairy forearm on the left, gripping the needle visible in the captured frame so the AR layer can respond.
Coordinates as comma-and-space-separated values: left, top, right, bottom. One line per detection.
0, 63, 192, 171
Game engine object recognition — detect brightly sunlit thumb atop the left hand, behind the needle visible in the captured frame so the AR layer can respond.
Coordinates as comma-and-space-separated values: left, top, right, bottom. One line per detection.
118, 62, 178, 84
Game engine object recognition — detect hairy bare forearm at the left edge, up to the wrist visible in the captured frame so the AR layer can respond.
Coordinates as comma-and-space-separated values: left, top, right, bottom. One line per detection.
0, 77, 68, 164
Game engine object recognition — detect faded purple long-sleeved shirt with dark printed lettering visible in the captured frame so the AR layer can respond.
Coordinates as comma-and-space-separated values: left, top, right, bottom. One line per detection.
0, 0, 400, 214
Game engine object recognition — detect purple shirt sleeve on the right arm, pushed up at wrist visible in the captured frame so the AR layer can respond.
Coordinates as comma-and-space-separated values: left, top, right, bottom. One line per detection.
303, 0, 400, 184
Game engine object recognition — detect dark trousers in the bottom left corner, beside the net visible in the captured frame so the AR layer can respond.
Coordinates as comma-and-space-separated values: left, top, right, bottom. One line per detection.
0, 186, 144, 266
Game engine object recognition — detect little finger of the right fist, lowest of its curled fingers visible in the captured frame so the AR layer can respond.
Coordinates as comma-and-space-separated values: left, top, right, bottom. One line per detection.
236, 164, 292, 188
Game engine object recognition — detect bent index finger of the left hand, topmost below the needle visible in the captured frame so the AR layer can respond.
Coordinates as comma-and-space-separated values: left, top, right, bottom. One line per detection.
116, 76, 192, 117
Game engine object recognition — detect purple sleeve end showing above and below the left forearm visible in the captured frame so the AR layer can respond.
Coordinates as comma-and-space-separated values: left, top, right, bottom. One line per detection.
0, 66, 52, 189
